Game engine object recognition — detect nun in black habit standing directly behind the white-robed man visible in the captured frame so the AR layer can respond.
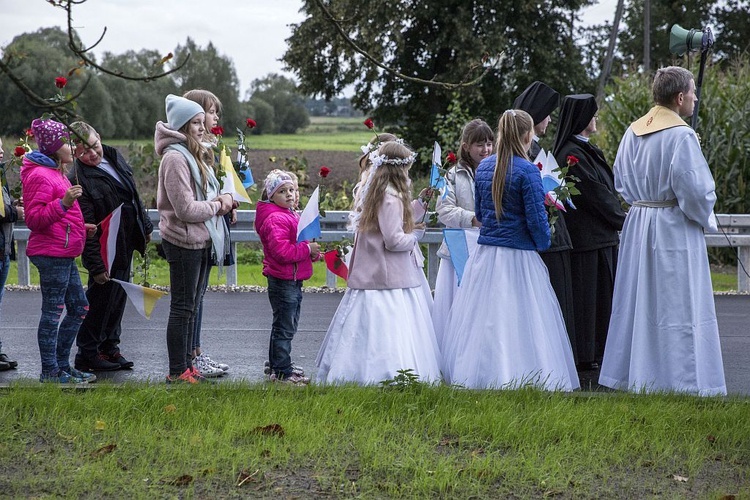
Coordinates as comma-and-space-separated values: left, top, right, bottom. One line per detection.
553, 94, 625, 370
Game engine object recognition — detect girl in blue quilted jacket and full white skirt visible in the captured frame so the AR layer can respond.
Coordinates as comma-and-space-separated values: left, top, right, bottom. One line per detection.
443, 110, 579, 391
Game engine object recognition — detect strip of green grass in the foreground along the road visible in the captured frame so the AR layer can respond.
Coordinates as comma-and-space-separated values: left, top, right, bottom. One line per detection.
0, 383, 750, 498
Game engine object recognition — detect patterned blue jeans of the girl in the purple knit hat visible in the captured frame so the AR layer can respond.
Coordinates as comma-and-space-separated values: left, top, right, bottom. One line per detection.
29, 255, 89, 376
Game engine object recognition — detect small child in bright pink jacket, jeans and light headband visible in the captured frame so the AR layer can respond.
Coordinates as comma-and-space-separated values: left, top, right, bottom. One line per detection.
255, 170, 320, 385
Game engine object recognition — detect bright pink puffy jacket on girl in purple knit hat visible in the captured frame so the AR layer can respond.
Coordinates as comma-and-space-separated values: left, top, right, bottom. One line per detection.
21, 151, 86, 258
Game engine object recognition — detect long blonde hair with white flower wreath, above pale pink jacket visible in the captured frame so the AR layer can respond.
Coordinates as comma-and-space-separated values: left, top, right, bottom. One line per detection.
359, 142, 415, 233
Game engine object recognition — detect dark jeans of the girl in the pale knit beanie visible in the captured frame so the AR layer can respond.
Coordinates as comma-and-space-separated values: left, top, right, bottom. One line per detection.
161, 240, 211, 376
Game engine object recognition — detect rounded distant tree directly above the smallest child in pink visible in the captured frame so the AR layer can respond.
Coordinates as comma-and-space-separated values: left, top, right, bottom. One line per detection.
248, 73, 310, 134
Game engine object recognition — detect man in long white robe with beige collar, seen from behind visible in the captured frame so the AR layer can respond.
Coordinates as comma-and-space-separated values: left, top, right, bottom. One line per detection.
599, 66, 726, 396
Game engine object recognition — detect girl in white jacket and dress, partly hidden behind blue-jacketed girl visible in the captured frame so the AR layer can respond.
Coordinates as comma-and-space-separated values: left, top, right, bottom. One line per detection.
432, 119, 495, 345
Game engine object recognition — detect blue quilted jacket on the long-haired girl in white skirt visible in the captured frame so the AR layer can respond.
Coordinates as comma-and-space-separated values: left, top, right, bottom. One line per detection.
474, 155, 550, 251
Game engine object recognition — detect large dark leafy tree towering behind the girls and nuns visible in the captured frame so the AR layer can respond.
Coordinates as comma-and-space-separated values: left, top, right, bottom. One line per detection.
282, 0, 594, 148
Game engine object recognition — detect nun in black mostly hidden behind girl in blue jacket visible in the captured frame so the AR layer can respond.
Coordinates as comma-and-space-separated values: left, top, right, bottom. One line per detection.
513, 81, 578, 363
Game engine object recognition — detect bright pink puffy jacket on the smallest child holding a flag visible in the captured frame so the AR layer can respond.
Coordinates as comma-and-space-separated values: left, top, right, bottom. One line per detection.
255, 201, 312, 280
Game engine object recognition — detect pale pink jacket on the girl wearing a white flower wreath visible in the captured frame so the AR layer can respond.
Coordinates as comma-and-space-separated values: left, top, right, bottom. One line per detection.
347, 189, 422, 290
